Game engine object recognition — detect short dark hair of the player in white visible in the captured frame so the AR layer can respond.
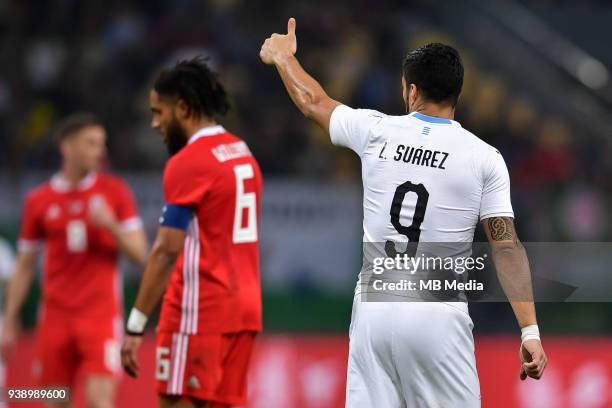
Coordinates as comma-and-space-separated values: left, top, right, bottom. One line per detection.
403, 43, 463, 106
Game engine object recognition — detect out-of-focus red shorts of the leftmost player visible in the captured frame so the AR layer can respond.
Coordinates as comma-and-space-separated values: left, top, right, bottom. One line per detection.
34, 315, 122, 386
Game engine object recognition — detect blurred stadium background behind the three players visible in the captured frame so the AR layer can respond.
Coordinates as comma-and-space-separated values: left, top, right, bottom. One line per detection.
0, 0, 612, 408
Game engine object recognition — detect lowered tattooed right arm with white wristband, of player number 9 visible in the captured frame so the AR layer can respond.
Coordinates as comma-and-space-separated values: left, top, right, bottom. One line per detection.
482, 217, 548, 380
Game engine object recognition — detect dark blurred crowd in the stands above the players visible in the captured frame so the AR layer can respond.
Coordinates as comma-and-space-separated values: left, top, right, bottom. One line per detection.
0, 0, 612, 241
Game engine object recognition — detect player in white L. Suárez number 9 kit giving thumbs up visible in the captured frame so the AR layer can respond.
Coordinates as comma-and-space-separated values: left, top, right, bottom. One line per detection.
260, 18, 547, 408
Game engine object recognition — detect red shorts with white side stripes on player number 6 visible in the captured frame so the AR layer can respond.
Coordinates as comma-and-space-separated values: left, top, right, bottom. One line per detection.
155, 331, 257, 406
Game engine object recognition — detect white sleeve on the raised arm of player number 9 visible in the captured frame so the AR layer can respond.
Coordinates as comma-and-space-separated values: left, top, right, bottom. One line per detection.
329, 105, 384, 156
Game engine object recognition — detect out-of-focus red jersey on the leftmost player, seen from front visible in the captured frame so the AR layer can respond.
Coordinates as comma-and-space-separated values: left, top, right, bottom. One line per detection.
19, 173, 142, 317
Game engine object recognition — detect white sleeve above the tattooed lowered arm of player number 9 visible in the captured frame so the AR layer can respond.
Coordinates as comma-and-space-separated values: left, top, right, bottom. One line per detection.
480, 150, 514, 220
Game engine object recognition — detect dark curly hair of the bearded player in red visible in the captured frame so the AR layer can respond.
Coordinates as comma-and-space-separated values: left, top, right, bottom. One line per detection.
153, 56, 230, 118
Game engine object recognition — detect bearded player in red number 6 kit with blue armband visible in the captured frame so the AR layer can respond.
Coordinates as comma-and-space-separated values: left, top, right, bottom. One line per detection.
121, 58, 262, 408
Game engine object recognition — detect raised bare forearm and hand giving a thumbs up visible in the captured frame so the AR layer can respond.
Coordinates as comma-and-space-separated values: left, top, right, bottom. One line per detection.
259, 17, 340, 133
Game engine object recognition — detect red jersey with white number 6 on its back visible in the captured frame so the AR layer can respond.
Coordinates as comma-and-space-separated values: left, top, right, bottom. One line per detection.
159, 126, 262, 334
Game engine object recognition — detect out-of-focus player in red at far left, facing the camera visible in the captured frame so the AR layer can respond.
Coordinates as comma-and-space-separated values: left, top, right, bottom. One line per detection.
0, 114, 147, 407
